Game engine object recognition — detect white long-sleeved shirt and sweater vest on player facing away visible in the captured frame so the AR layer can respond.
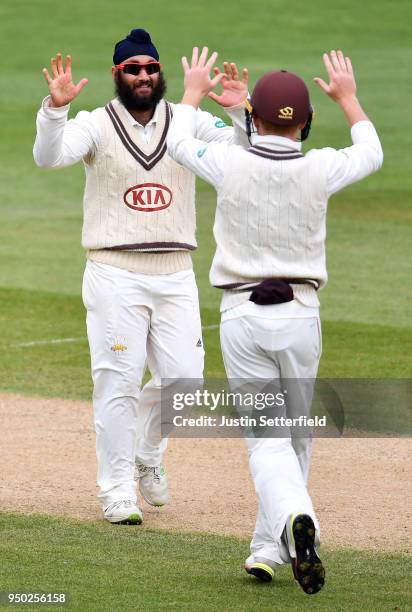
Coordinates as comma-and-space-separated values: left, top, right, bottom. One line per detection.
168, 104, 383, 311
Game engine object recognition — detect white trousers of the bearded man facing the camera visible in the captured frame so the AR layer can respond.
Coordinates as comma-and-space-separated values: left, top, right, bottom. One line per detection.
83, 261, 204, 508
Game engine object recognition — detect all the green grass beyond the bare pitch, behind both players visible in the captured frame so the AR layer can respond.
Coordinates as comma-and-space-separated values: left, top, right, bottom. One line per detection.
0, 0, 412, 398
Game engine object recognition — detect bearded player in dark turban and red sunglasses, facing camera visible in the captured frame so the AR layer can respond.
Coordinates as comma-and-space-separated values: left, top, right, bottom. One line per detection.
34, 29, 247, 524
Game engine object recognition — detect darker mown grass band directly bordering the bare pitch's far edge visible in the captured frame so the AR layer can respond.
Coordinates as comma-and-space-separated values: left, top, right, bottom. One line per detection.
0, 289, 412, 399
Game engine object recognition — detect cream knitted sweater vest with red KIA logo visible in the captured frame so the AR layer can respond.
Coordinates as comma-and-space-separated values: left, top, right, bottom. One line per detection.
82, 99, 197, 267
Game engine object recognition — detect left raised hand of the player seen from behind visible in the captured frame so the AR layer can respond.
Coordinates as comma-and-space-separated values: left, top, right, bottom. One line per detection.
182, 47, 226, 106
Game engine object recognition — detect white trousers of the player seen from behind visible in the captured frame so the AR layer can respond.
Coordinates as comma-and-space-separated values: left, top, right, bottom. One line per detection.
220, 302, 321, 564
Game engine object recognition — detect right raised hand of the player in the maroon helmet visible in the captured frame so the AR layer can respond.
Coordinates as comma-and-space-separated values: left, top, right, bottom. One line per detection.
313, 51, 356, 102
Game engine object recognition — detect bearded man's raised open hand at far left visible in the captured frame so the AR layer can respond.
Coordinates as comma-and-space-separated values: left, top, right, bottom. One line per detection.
43, 53, 88, 106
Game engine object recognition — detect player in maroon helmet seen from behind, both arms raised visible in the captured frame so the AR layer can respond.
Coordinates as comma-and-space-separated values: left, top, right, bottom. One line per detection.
168, 49, 383, 594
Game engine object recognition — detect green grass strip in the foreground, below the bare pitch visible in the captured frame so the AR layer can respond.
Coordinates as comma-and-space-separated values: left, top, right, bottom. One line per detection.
0, 514, 410, 612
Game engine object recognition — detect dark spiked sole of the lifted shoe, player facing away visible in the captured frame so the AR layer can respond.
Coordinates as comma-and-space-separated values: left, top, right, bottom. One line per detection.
286, 514, 325, 595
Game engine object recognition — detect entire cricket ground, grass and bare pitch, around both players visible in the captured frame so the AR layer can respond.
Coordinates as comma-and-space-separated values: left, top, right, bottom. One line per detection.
0, 0, 412, 611
